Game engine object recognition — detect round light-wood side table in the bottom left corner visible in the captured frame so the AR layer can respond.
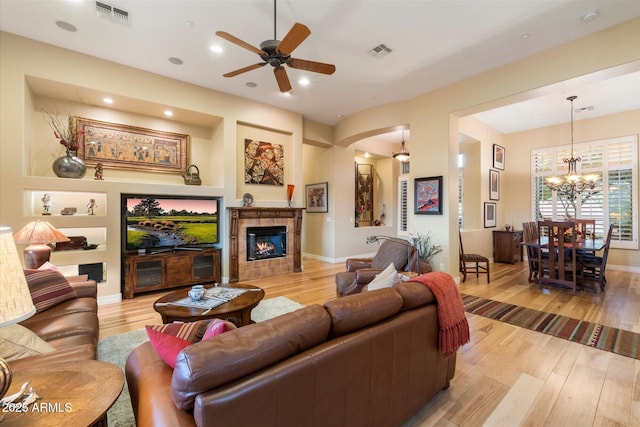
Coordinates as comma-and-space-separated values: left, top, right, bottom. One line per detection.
1, 360, 124, 427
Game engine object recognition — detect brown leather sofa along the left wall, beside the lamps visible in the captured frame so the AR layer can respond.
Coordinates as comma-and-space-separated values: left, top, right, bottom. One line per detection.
9, 280, 100, 370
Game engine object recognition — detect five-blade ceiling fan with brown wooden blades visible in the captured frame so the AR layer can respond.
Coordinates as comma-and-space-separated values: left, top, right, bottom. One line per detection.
216, 0, 336, 92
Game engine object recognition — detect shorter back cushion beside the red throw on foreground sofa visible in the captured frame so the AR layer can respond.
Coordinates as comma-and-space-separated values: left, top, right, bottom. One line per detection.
324, 288, 402, 338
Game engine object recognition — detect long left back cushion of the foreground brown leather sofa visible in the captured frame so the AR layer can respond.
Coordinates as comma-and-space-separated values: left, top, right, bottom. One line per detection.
171, 305, 331, 410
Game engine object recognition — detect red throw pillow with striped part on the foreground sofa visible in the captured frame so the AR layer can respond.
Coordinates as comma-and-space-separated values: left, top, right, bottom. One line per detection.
145, 319, 235, 368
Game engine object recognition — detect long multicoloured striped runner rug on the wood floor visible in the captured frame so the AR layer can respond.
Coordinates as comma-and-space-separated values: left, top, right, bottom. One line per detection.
462, 294, 640, 359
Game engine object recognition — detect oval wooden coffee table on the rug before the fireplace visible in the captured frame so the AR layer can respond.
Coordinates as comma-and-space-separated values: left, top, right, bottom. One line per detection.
153, 283, 264, 326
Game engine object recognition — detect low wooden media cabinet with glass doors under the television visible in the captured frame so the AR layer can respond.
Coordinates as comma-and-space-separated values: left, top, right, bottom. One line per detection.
122, 248, 222, 298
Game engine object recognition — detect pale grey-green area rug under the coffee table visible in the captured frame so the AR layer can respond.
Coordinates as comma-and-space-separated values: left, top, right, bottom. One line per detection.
98, 297, 304, 427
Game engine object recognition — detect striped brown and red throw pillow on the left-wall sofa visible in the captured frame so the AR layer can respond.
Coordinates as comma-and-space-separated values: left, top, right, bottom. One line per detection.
25, 270, 77, 313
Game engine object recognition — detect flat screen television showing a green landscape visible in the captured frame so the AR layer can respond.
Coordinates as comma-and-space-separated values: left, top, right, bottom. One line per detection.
121, 194, 220, 252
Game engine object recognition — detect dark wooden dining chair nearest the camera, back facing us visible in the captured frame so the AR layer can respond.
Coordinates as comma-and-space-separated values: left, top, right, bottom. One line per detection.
538, 221, 583, 295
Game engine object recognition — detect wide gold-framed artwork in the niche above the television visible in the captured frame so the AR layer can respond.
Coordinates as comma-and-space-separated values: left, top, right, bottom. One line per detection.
72, 117, 189, 173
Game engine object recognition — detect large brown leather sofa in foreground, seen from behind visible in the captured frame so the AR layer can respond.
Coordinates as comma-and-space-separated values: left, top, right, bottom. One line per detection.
125, 282, 456, 427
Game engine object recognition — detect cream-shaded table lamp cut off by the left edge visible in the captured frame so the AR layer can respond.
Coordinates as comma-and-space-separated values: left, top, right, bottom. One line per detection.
0, 227, 36, 398
